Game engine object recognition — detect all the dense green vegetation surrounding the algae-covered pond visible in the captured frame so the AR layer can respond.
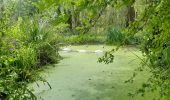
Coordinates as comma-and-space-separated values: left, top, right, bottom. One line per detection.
0, 0, 170, 99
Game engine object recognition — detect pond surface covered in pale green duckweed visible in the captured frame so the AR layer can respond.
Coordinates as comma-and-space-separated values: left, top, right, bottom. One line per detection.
31, 45, 158, 100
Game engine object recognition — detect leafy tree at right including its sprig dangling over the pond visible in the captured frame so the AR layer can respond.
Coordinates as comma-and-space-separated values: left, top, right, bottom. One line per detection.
99, 0, 170, 99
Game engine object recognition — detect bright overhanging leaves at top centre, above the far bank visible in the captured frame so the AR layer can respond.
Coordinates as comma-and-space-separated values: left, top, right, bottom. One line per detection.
34, 0, 114, 34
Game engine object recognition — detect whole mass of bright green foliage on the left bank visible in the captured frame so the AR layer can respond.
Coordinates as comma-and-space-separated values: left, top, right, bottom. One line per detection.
0, 0, 60, 100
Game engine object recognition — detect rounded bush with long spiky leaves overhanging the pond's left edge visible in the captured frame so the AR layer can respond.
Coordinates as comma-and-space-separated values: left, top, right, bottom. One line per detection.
22, 19, 61, 66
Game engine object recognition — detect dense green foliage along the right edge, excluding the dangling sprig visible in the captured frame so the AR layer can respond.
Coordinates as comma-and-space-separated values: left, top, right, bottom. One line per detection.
124, 0, 170, 98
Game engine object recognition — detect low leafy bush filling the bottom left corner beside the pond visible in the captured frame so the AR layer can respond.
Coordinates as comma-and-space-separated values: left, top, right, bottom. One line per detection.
0, 48, 37, 100
